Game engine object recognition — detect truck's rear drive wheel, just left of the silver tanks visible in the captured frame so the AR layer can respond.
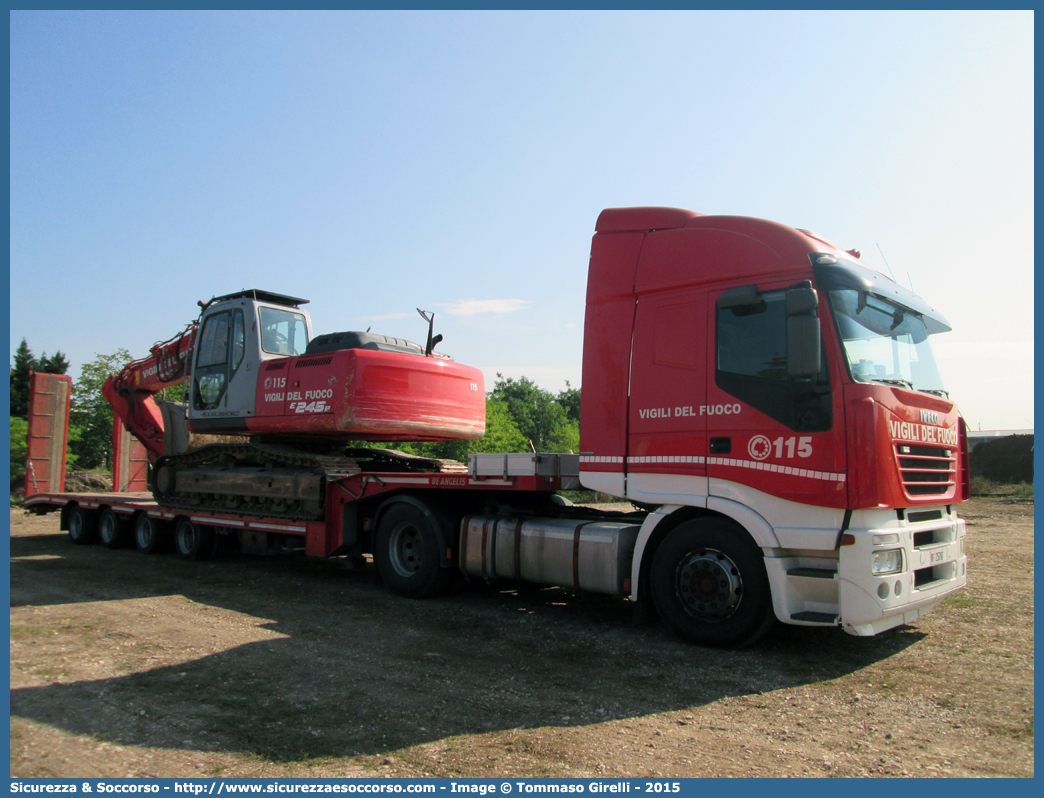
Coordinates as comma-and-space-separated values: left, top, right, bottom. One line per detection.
374, 504, 453, 599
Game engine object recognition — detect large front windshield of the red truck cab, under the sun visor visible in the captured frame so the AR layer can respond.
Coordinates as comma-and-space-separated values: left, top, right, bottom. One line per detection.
829, 288, 947, 395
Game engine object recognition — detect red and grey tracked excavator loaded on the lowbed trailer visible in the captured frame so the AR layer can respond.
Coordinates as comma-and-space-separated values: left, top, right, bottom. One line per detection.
102, 289, 485, 518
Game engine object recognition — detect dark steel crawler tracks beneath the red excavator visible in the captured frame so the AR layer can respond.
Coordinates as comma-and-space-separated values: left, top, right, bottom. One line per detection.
151, 443, 467, 521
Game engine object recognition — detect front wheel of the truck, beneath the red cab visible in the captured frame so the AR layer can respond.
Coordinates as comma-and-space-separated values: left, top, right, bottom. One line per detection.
649, 518, 776, 648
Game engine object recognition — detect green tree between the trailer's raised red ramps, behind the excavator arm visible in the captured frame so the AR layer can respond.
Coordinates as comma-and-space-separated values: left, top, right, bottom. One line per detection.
69, 349, 131, 469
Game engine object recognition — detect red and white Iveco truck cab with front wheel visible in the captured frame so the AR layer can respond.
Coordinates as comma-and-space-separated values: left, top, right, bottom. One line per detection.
580, 208, 969, 637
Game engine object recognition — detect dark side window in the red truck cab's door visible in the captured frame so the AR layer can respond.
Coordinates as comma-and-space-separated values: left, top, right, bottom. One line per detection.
714, 291, 833, 432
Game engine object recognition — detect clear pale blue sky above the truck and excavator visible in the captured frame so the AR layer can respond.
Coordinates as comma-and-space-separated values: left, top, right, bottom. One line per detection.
10, 11, 1034, 429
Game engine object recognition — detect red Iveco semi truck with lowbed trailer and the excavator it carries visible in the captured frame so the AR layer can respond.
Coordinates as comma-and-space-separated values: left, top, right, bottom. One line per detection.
26, 208, 969, 647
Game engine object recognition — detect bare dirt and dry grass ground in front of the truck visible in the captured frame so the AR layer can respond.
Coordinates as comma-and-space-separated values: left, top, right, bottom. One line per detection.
10, 499, 1034, 777
